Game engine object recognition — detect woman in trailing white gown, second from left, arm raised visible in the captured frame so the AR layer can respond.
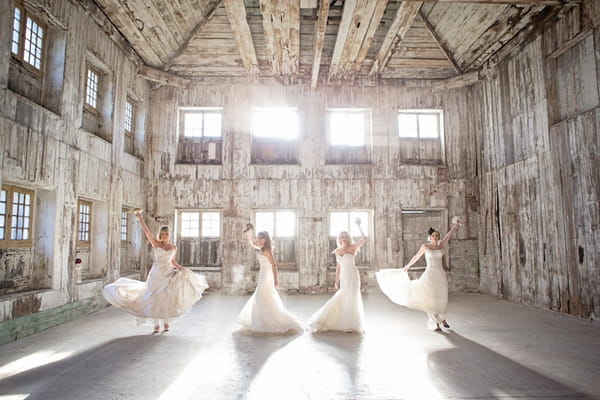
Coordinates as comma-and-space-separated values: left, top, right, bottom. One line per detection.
237, 224, 302, 334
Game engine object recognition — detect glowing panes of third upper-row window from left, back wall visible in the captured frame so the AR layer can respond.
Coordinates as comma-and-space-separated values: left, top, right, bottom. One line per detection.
328, 110, 369, 147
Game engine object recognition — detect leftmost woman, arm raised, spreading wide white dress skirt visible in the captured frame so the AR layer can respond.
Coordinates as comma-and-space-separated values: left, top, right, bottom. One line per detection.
102, 209, 208, 333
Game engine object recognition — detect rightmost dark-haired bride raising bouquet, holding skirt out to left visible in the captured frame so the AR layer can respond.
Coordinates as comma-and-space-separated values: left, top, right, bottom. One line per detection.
375, 217, 462, 332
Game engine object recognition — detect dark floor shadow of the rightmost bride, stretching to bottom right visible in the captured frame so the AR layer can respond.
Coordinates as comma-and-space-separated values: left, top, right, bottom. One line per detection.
427, 332, 593, 400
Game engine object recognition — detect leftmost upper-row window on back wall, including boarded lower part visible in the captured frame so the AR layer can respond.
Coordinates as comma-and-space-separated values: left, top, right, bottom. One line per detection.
178, 107, 223, 164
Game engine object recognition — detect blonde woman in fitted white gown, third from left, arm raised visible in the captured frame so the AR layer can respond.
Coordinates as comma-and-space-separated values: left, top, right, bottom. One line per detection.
308, 219, 368, 333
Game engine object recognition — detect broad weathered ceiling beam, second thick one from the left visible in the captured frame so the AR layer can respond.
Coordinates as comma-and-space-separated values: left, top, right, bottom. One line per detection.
260, 0, 300, 83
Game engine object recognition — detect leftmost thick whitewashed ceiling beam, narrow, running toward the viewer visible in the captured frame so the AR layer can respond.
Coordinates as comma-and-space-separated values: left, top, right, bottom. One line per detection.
225, 0, 260, 77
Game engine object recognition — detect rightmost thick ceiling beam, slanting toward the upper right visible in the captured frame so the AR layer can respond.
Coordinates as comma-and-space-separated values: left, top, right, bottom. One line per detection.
369, 1, 423, 78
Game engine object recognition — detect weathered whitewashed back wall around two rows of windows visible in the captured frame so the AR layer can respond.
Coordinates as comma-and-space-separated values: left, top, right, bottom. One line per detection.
146, 85, 479, 292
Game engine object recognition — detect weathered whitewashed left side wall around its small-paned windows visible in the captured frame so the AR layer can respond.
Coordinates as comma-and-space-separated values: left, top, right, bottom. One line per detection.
0, 1, 148, 324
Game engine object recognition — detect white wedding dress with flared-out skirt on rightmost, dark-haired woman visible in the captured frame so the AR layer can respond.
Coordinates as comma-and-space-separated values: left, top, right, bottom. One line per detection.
375, 249, 448, 329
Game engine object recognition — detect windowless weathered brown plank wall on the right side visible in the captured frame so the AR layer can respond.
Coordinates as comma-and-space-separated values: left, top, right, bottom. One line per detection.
470, 1, 600, 319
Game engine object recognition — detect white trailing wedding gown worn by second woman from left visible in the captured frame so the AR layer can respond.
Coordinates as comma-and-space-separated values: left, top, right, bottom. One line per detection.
237, 253, 302, 334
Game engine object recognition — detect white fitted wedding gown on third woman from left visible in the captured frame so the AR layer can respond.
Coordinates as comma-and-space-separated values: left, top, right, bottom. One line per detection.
308, 253, 364, 333
